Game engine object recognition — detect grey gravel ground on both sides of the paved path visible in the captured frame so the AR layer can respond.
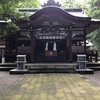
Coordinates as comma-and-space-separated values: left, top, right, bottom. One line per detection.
0, 71, 100, 95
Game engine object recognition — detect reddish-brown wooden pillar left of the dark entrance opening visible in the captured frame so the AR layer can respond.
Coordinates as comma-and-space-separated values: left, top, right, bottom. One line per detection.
30, 29, 35, 62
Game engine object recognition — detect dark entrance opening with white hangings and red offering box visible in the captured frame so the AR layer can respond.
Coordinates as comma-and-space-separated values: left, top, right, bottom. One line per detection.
35, 36, 68, 63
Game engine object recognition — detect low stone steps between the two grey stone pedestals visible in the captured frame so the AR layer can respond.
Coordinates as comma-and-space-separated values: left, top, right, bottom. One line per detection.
26, 63, 76, 74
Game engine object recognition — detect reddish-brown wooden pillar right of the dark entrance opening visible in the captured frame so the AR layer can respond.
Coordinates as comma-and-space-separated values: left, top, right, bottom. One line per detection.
68, 27, 72, 62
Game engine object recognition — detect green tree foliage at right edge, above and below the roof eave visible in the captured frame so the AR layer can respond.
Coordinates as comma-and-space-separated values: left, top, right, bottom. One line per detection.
87, 0, 100, 51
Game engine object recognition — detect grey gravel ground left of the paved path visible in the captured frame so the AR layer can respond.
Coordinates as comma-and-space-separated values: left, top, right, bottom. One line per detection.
0, 71, 23, 95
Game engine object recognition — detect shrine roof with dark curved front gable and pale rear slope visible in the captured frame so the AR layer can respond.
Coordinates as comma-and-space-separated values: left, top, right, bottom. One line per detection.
18, 6, 100, 34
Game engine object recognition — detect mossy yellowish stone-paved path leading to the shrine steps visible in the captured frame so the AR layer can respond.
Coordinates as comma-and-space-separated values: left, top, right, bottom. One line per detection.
0, 74, 100, 100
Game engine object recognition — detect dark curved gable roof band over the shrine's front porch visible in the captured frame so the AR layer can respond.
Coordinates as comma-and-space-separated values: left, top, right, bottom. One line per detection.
30, 6, 91, 22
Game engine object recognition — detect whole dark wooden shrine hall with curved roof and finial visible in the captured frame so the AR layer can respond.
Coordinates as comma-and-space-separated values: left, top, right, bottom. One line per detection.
1, 0, 100, 63
